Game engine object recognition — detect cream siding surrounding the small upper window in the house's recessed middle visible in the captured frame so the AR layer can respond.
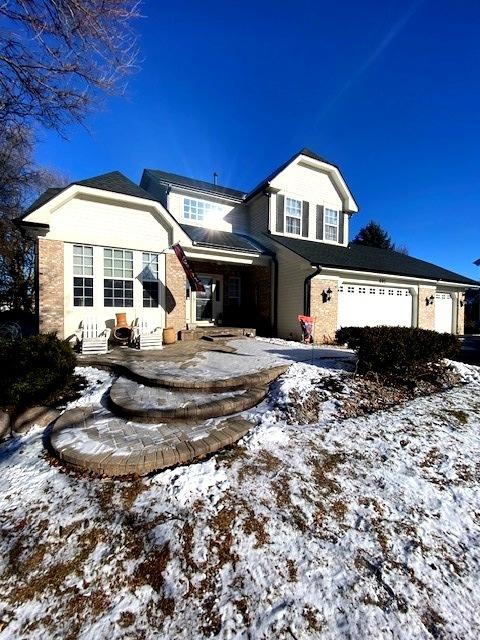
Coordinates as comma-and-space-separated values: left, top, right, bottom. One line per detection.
168, 190, 247, 232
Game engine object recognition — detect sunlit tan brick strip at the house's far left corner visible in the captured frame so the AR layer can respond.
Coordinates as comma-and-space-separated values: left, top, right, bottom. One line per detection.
37, 238, 64, 338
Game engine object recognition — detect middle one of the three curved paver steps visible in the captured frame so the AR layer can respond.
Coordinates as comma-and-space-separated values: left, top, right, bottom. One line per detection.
109, 378, 268, 423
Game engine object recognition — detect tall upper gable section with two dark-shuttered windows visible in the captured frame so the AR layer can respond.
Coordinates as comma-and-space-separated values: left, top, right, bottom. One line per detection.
246, 149, 358, 246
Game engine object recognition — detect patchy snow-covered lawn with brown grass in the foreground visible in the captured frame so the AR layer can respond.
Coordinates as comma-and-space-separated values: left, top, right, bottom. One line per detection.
0, 363, 480, 640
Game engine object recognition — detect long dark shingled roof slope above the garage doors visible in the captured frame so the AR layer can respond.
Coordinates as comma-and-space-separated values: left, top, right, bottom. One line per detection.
264, 233, 479, 285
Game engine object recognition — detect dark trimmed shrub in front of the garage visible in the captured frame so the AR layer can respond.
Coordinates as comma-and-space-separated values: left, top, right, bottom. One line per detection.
336, 326, 460, 375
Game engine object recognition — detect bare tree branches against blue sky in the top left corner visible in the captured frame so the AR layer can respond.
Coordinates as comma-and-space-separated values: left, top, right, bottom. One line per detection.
0, 0, 140, 131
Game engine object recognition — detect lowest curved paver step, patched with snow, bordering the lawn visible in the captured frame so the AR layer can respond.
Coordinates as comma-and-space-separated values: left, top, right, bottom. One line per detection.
46, 407, 254, 476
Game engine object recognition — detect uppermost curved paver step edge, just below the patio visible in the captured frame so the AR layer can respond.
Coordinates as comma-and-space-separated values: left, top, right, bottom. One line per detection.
82, 358, 291, 391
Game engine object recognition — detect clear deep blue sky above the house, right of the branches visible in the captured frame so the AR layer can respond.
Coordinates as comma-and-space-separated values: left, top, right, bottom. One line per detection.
37, 0, 480, 278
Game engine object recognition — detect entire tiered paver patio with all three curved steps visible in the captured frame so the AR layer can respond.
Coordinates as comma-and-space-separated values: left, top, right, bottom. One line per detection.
47, 338, 352, 476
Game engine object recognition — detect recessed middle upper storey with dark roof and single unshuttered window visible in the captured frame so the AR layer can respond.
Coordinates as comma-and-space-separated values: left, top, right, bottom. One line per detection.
140, 169, 247, 232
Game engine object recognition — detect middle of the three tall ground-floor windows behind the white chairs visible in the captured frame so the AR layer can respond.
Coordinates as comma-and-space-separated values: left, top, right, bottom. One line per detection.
103, 249, 133, 307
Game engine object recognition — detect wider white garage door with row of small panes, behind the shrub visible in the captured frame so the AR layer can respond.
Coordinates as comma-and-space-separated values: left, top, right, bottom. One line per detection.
338, 282, 413, 327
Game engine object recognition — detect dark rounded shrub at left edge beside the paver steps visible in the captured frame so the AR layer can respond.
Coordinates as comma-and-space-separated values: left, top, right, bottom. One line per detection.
0, 335, 76, 410
